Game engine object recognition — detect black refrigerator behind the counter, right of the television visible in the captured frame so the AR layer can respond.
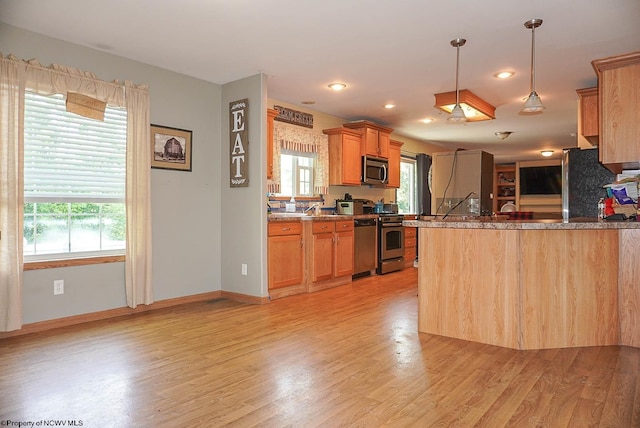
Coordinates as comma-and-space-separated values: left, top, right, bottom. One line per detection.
562, 147, 616, 220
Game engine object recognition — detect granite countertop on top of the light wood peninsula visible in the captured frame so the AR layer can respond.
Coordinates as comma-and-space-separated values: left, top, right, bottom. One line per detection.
402, 217, 640, 230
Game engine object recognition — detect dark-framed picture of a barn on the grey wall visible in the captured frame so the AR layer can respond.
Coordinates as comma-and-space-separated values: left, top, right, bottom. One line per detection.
151, 124, 192, 171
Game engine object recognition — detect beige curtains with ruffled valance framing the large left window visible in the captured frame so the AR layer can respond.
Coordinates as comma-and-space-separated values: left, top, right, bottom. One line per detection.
0, 54, 153, 330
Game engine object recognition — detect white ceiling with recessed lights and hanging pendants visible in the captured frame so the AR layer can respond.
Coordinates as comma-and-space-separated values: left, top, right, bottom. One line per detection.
0, 0, 640, 162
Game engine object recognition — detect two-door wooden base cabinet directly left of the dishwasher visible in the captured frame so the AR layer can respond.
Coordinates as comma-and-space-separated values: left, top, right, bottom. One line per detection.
306, 220, 354, 291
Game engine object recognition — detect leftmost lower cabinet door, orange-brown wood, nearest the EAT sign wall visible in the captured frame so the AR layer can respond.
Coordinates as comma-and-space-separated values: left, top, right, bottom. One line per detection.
268, 235, 303, 290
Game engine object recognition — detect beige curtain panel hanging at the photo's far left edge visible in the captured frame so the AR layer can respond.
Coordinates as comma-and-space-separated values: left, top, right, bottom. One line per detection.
0, 54, 25, 331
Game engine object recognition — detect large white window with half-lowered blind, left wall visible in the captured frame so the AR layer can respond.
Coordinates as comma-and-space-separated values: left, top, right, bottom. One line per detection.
24, 91, 127, 261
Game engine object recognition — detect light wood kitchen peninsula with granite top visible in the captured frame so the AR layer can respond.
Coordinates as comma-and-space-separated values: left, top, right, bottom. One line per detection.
404, 218, 640, 349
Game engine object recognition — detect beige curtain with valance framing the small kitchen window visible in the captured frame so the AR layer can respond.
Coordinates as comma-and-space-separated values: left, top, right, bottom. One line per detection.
267, 122, 329, 195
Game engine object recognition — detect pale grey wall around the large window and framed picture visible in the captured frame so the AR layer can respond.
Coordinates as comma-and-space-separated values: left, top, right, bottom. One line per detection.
0, 23, 225, 324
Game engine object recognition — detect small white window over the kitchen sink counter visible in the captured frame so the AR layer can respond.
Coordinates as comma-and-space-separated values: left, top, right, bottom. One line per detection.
280, 150, 315, 196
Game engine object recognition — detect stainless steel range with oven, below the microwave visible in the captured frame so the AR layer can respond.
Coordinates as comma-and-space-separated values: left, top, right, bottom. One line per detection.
376, 213, 404, 275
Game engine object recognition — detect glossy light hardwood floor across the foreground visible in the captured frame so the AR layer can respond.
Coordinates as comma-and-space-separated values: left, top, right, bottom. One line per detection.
0, 268, 640, 427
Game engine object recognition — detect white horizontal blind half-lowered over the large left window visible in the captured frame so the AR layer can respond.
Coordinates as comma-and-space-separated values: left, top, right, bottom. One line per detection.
24, 91, 127, 203
